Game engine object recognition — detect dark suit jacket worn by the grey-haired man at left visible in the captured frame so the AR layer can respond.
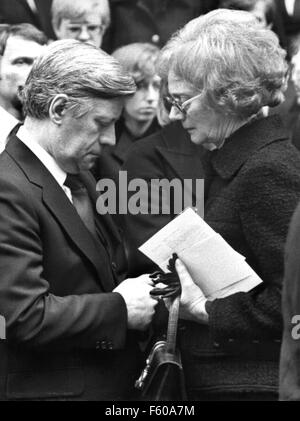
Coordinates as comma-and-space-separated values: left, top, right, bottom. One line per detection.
0, 136, 139, 400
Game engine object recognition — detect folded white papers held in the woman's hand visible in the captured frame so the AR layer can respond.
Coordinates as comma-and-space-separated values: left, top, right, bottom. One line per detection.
139, 208, 262, 299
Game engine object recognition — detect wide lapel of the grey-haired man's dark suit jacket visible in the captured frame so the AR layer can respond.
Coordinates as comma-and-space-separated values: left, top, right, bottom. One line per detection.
6, 136, 116, 291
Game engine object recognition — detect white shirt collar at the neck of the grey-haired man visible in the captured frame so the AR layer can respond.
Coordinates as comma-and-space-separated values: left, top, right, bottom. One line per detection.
17, 126, 67, 189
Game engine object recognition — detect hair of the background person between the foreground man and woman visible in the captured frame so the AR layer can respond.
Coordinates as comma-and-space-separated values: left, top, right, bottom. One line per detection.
112, 42, 160, 84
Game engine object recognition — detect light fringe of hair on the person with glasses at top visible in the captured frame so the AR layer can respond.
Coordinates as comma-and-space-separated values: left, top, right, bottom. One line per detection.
51, 0, 110, 28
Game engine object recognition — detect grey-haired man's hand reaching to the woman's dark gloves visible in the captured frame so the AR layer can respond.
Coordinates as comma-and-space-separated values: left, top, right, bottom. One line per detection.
113, 275, 157, 330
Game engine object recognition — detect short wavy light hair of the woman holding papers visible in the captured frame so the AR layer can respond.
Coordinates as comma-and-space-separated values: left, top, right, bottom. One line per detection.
159, 9, 288, 119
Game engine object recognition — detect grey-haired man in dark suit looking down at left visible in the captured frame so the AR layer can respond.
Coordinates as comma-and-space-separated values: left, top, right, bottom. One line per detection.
0, 40, 156, 400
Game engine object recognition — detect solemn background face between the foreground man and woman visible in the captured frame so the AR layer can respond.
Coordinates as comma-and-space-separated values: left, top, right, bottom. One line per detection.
124, 75, 160, 123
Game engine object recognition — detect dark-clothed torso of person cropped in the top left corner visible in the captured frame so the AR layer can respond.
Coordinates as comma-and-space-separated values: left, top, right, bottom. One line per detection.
0, 0, 56, 39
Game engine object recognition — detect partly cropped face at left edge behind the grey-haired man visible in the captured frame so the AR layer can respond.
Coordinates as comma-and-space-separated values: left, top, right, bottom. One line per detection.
0, 36, 44, 118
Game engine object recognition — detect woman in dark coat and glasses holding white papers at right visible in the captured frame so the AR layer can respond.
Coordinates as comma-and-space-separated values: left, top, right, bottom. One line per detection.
156, 10, 300, 400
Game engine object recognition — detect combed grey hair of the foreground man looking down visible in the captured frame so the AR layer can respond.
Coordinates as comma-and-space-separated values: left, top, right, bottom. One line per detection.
22, 40, 136, 120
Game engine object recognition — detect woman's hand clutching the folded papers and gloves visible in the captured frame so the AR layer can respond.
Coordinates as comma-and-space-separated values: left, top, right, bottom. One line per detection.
176, 259, 208, 324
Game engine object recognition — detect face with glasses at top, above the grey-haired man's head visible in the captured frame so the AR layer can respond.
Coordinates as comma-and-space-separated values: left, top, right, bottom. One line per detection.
55, 10, 106, 47
